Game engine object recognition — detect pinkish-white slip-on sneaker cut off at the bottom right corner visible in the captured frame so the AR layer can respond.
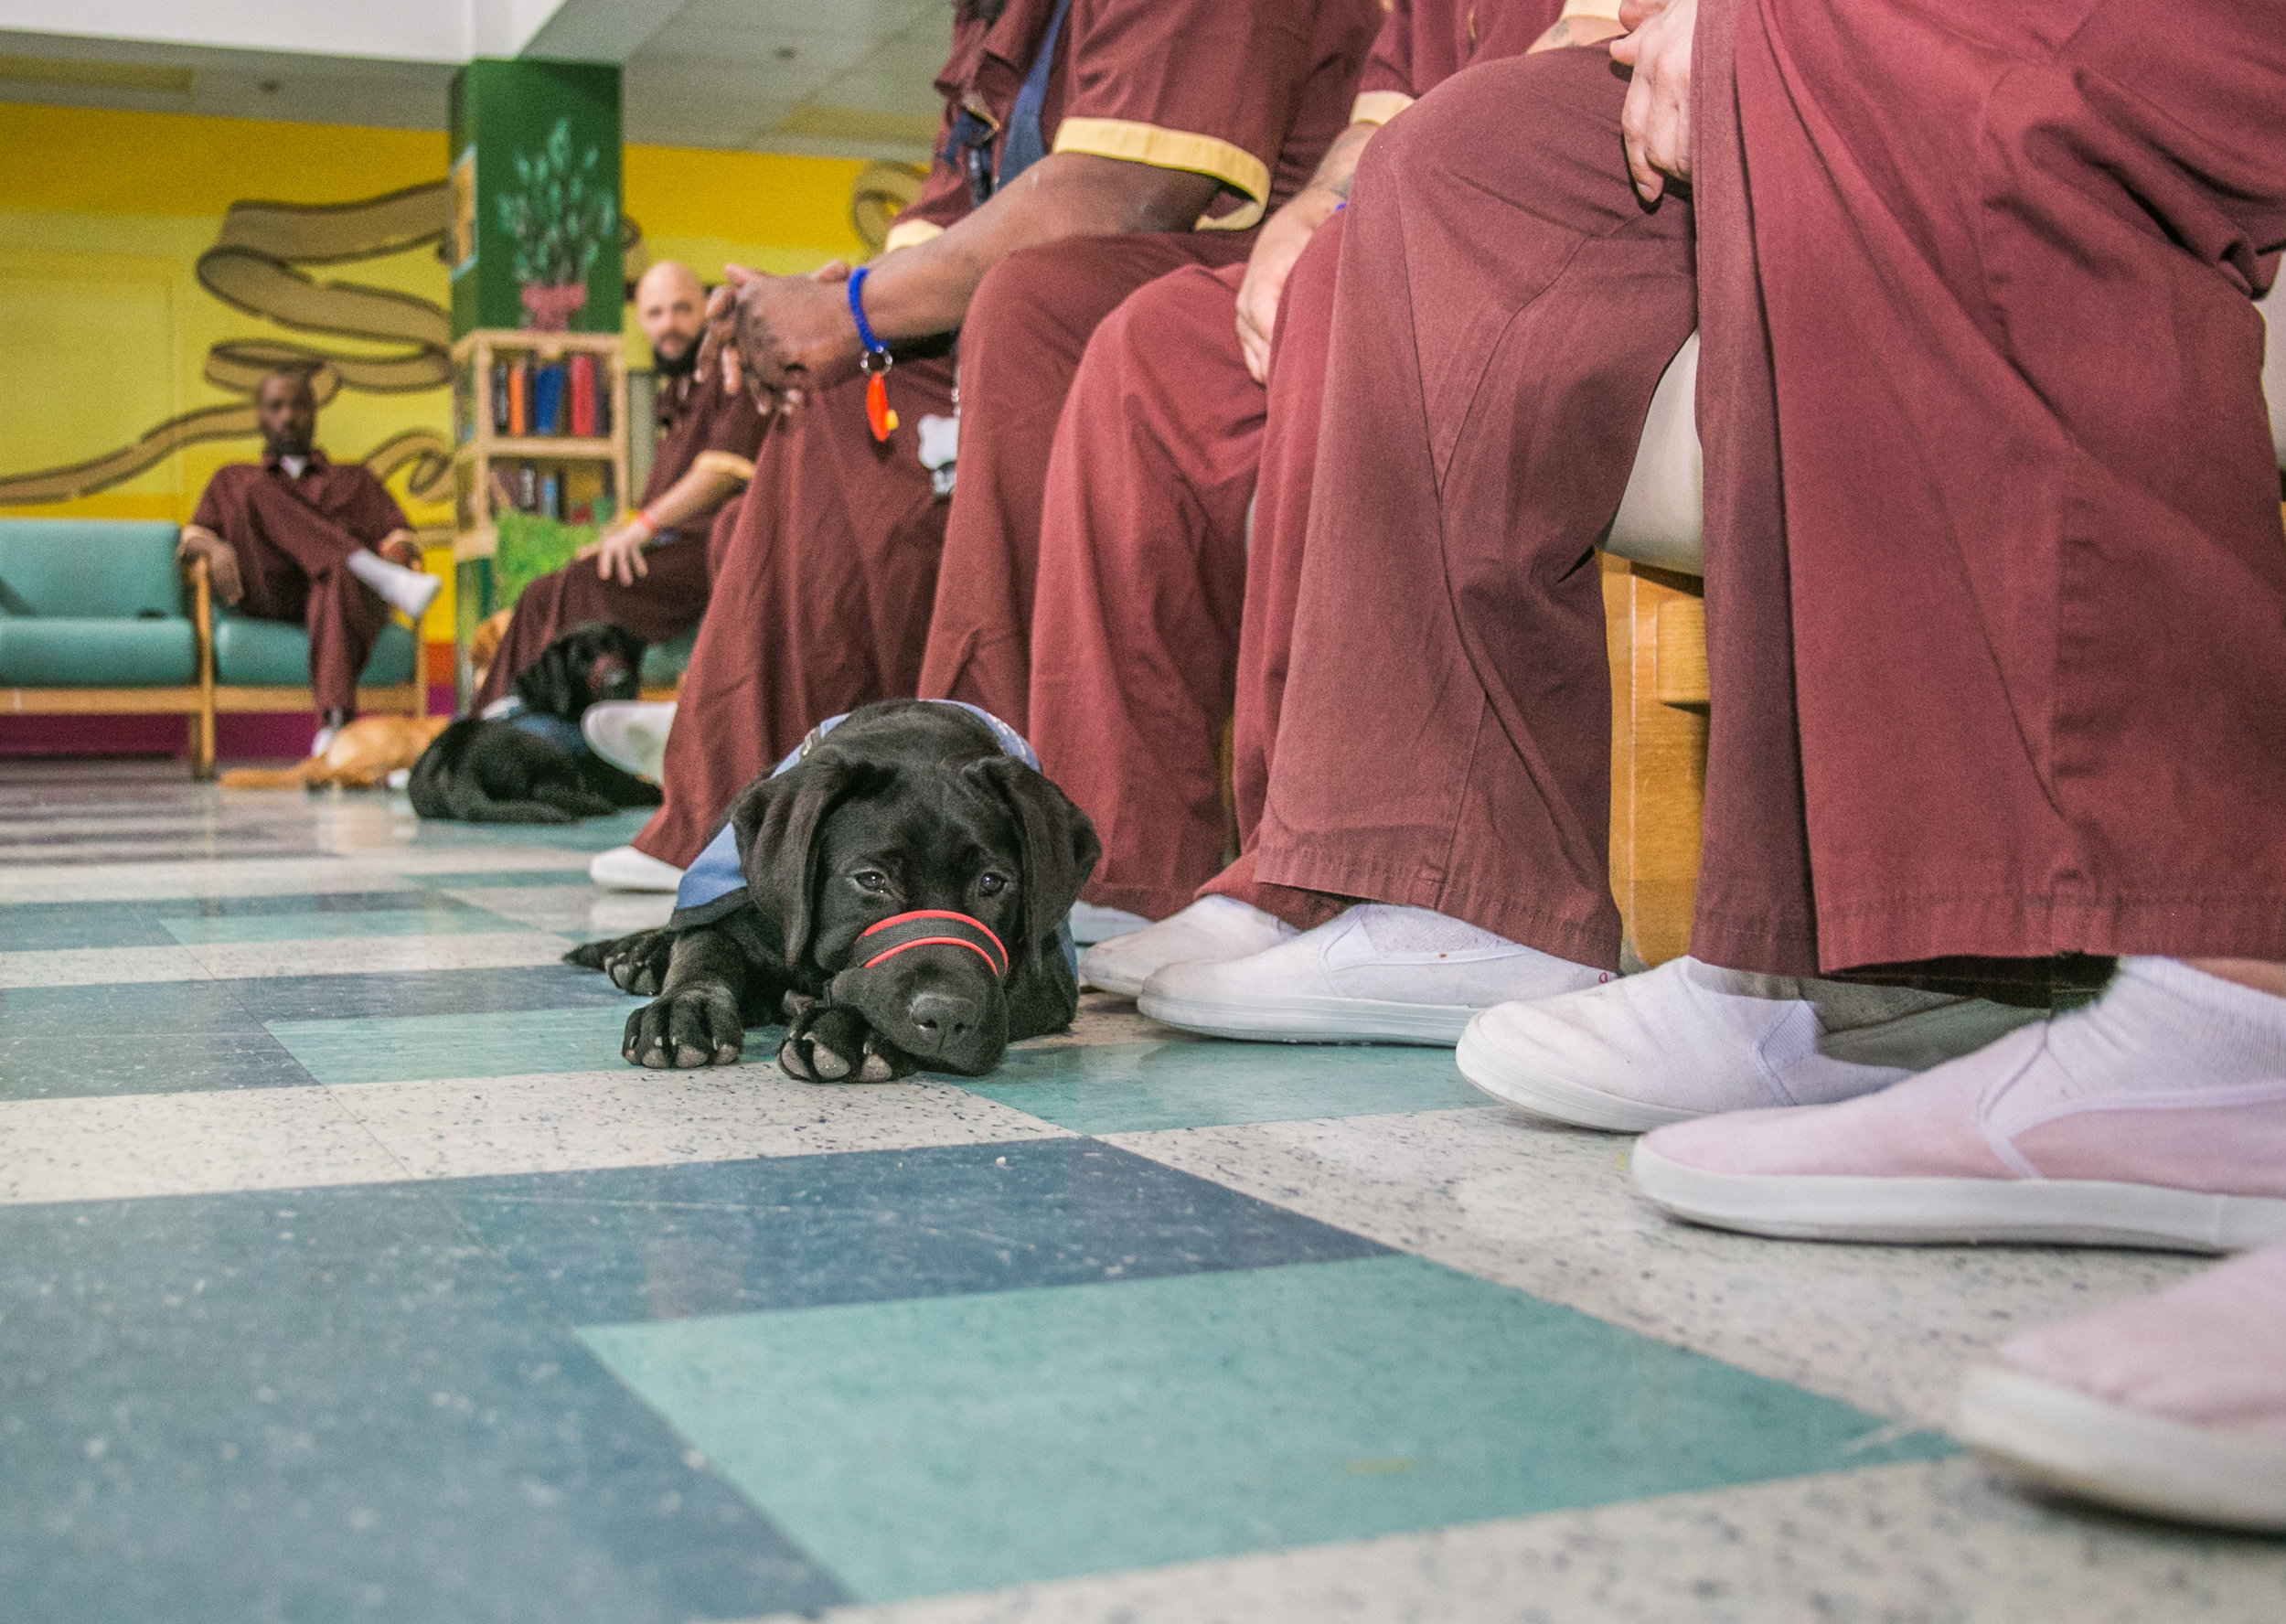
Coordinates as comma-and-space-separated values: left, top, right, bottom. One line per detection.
1952, 1246, 2286, 1533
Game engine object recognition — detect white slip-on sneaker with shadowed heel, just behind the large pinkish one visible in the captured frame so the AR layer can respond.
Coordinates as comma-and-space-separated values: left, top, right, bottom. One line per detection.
1454, 958, 2042, 1132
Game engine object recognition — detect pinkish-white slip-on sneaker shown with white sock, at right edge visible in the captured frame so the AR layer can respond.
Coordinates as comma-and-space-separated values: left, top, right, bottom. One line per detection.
1630, 958, 2286, 1251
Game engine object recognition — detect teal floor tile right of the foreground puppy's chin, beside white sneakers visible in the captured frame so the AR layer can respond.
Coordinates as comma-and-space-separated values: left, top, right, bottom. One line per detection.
951, 1039, 1490, 1135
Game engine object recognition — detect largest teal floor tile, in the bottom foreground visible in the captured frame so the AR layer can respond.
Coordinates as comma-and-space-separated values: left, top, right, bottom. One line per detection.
581, 1258, 1950, 1601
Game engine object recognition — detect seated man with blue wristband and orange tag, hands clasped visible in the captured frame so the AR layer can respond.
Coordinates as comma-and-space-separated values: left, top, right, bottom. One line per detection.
590, 0, 1376, 890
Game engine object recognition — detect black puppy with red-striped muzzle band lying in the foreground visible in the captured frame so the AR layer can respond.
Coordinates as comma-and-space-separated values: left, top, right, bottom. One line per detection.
567, 700, 1102, 1082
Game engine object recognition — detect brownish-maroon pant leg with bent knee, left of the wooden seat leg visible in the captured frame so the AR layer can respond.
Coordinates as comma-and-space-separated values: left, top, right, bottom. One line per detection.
1255, 50, 1696, 966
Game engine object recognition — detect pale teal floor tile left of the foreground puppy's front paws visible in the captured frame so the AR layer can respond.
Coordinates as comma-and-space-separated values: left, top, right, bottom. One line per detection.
268, 999, 634, 1084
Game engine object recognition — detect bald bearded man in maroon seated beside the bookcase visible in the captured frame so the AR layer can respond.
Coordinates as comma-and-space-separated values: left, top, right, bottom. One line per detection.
475, 259, 764, 707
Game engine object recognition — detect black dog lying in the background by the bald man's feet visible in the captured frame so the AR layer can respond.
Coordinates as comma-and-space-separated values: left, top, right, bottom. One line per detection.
407, 620, 661, 824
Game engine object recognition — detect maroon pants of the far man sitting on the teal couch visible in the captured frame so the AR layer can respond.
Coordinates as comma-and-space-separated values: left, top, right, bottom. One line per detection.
222, 478, 389, 711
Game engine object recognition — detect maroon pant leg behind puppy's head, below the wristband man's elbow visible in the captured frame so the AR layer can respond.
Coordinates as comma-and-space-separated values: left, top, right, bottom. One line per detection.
919, 231, 1253, 732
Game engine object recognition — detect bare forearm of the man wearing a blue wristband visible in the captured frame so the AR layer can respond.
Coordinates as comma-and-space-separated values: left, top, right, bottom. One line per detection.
864, 154, 1221, 338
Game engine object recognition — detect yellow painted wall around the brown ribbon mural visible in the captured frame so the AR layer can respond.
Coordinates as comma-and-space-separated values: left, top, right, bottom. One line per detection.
0, 103, 864, 535
